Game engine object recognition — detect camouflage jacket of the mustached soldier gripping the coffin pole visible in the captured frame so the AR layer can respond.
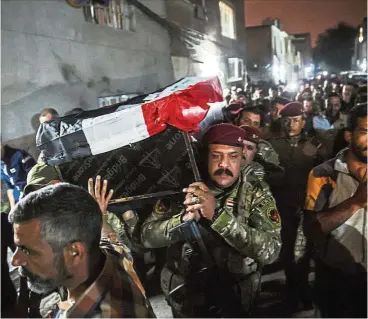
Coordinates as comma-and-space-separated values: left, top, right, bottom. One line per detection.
141, 170, 281, 277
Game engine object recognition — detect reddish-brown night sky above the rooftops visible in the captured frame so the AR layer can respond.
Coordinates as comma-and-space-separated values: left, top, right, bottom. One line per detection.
245, 0, 367, 46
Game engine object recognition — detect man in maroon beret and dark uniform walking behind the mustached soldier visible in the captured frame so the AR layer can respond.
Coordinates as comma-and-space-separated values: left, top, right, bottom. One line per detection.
267, 102, 324, 311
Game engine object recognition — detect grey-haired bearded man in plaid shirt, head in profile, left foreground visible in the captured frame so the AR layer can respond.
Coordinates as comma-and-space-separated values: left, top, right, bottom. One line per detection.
9, 184, 154, 318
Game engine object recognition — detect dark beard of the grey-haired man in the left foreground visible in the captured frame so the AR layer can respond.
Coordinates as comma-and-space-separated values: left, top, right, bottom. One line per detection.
19, 253, 73, 294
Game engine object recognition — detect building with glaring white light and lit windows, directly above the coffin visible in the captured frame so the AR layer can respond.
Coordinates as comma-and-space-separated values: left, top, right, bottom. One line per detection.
166, 0, 246, 88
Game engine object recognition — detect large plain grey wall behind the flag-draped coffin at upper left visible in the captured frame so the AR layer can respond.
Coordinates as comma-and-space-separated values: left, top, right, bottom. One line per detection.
1, 0, 173, 156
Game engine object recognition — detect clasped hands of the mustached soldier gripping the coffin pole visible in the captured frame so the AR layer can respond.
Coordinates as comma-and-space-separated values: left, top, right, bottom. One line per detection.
183, 182, 216, 220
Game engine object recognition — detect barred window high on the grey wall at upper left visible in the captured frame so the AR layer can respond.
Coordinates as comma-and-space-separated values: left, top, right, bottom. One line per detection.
83, 0, 135, 31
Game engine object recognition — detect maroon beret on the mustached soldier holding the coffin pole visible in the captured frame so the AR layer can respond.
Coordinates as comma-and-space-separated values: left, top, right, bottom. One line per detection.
203, 123, 245, 147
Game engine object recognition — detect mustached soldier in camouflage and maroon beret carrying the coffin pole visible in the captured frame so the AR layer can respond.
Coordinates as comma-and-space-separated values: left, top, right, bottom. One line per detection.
141, 124, 281, 317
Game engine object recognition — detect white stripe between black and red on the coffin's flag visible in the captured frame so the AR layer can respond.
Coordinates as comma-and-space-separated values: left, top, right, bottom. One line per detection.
82, 104, 150, 155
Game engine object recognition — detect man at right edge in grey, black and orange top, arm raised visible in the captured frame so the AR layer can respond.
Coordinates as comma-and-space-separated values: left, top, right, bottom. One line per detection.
304, 103, 368, 318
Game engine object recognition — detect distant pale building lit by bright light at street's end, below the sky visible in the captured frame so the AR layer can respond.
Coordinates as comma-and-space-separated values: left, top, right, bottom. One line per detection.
245, 19, 301, 84
